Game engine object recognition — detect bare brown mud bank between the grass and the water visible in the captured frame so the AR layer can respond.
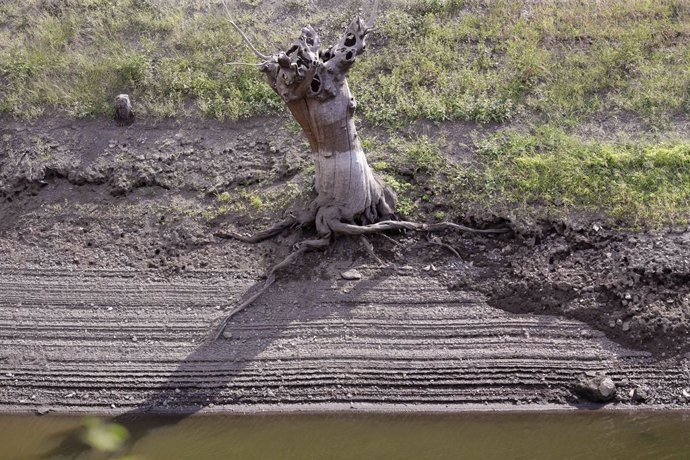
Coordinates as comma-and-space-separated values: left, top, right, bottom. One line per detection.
0, 119, 690, 413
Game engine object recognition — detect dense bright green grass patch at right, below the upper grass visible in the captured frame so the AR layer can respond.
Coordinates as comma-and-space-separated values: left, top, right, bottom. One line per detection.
475, 126, 690, 226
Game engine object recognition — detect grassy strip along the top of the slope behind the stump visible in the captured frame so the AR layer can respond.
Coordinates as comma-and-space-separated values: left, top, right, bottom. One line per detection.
0, 0, 690, 127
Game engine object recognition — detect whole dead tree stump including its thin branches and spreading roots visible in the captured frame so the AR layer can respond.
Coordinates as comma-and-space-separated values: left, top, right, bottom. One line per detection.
214, 1, 507, 339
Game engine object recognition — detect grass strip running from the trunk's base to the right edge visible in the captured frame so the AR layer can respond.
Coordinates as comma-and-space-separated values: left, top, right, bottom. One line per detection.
360, 125, 690, 228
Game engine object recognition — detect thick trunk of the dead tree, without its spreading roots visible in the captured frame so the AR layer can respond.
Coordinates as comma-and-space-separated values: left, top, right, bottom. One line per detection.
261, 18, 395, 237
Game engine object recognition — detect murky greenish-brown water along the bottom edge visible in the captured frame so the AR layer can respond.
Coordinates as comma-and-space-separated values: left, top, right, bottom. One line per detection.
0, 412, 690, 460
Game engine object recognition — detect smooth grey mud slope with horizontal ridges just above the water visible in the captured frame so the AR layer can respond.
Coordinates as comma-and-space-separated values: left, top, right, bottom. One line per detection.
0, 263, 688, 412
